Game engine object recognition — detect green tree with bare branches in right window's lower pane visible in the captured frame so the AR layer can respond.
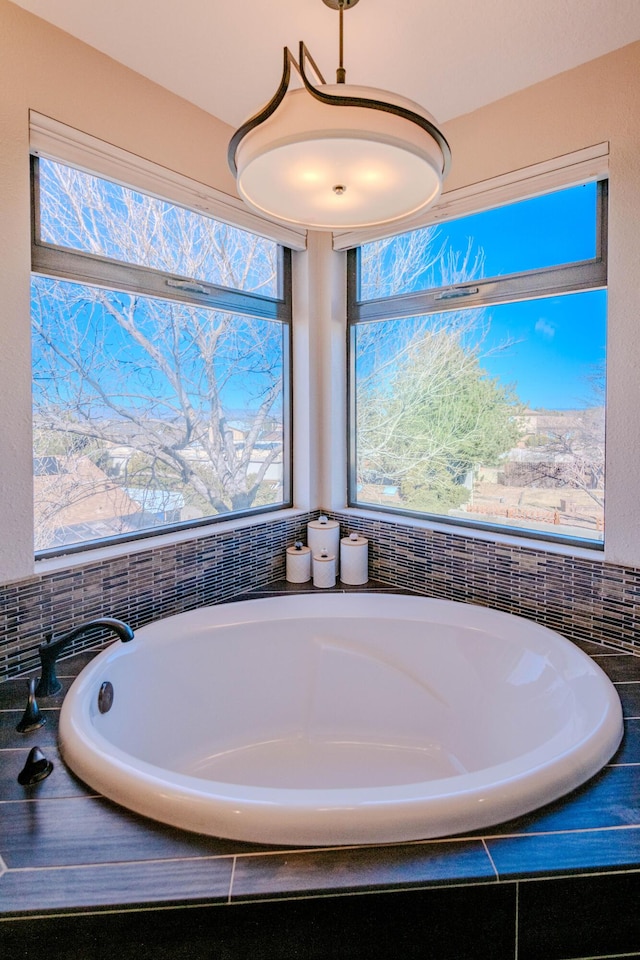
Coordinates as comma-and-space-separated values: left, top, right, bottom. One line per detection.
357, 311, 520, 513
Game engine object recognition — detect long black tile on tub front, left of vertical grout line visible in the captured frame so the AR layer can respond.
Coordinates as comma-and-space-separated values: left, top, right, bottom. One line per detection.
0, 884, 516, 960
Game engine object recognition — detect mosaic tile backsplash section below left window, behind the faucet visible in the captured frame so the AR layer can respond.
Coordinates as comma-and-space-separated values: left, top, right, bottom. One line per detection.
0, 513, 317, 678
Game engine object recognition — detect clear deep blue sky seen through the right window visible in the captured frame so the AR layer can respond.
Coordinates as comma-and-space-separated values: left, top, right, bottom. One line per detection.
430, 183, 606, 409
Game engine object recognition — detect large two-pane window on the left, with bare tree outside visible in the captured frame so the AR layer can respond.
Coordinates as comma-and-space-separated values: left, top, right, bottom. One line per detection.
32, 157, 291, 553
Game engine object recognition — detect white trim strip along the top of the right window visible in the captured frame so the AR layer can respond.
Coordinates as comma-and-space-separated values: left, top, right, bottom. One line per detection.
333, 142, 609, 250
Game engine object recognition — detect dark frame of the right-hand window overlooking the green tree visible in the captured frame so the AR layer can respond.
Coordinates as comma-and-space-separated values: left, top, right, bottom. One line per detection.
347, 174, 609, 551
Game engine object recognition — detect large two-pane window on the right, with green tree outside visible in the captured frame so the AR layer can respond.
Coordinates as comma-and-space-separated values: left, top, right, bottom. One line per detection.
348, 181, 606, 544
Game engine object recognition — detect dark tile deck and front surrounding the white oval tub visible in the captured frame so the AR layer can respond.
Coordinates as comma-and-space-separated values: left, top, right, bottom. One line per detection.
0, 591, 640, 960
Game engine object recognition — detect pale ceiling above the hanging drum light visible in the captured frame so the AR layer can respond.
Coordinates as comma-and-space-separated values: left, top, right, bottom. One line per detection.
8, 0, 640, 126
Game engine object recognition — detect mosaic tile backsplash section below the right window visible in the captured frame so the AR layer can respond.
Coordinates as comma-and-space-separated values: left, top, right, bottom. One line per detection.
330, 513, 640, 654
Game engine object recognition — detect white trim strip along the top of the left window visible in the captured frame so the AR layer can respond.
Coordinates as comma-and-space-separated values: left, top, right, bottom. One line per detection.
29, 110, 307, 250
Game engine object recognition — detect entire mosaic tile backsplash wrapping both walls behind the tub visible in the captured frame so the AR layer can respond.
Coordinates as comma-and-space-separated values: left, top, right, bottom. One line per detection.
0, 511, 640, 678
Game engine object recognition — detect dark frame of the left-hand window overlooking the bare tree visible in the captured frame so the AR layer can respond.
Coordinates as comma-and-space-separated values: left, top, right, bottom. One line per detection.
30, 150, 293, 561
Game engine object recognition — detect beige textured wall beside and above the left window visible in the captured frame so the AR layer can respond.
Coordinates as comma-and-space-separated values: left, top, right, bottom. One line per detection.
0, 0, 235, 582
